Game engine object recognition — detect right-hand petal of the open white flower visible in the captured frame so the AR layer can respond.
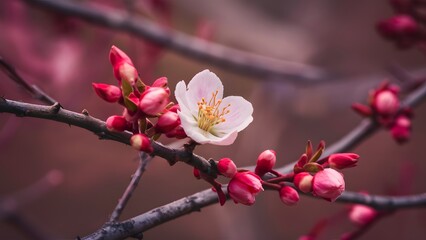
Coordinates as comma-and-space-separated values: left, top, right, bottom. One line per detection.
213, 96, 253, 135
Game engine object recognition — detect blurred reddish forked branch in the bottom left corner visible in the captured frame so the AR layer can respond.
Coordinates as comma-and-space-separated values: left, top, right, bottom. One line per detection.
0, 170, 63, 240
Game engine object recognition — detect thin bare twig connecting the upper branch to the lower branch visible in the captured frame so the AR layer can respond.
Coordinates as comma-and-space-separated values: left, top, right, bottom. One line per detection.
109, 152, 152, 222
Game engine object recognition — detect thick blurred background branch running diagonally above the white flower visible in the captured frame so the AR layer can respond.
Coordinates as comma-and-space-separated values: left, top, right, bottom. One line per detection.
24, 0, 331, 83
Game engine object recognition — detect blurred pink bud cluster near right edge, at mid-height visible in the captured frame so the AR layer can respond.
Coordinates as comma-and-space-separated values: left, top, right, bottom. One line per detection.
352, 82, 412, 143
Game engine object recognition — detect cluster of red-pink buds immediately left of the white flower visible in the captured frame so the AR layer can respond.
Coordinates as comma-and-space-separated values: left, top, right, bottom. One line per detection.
92, 46, 186, 153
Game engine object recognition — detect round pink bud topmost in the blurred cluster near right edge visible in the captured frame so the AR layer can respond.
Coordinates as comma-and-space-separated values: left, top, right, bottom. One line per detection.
373, 90, 399, 116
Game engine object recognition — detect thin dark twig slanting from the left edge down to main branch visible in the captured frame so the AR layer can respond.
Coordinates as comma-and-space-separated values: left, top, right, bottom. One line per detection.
0, 56, 56, 105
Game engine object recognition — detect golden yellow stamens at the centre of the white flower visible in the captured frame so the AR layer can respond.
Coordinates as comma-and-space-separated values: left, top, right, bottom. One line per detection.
197, 90, 231, 132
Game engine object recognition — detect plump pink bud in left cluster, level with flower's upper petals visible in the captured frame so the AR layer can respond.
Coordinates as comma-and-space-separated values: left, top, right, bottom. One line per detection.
139, 87, 169, 116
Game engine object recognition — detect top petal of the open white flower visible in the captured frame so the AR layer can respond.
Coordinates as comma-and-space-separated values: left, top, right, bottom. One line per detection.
186, 69, 223, 111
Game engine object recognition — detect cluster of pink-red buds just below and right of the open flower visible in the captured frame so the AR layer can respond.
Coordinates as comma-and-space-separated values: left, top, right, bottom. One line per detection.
194, 141, 359, 206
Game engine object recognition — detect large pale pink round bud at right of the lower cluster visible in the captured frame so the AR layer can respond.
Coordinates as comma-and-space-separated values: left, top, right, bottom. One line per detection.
312, 168, 345, 202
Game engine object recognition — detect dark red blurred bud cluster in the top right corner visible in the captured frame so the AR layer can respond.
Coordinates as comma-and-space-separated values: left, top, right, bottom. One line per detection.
377, 0, 426, 48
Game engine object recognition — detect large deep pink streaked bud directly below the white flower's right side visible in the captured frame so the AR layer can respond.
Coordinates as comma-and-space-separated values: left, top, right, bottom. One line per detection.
228, 172, 263, 206
